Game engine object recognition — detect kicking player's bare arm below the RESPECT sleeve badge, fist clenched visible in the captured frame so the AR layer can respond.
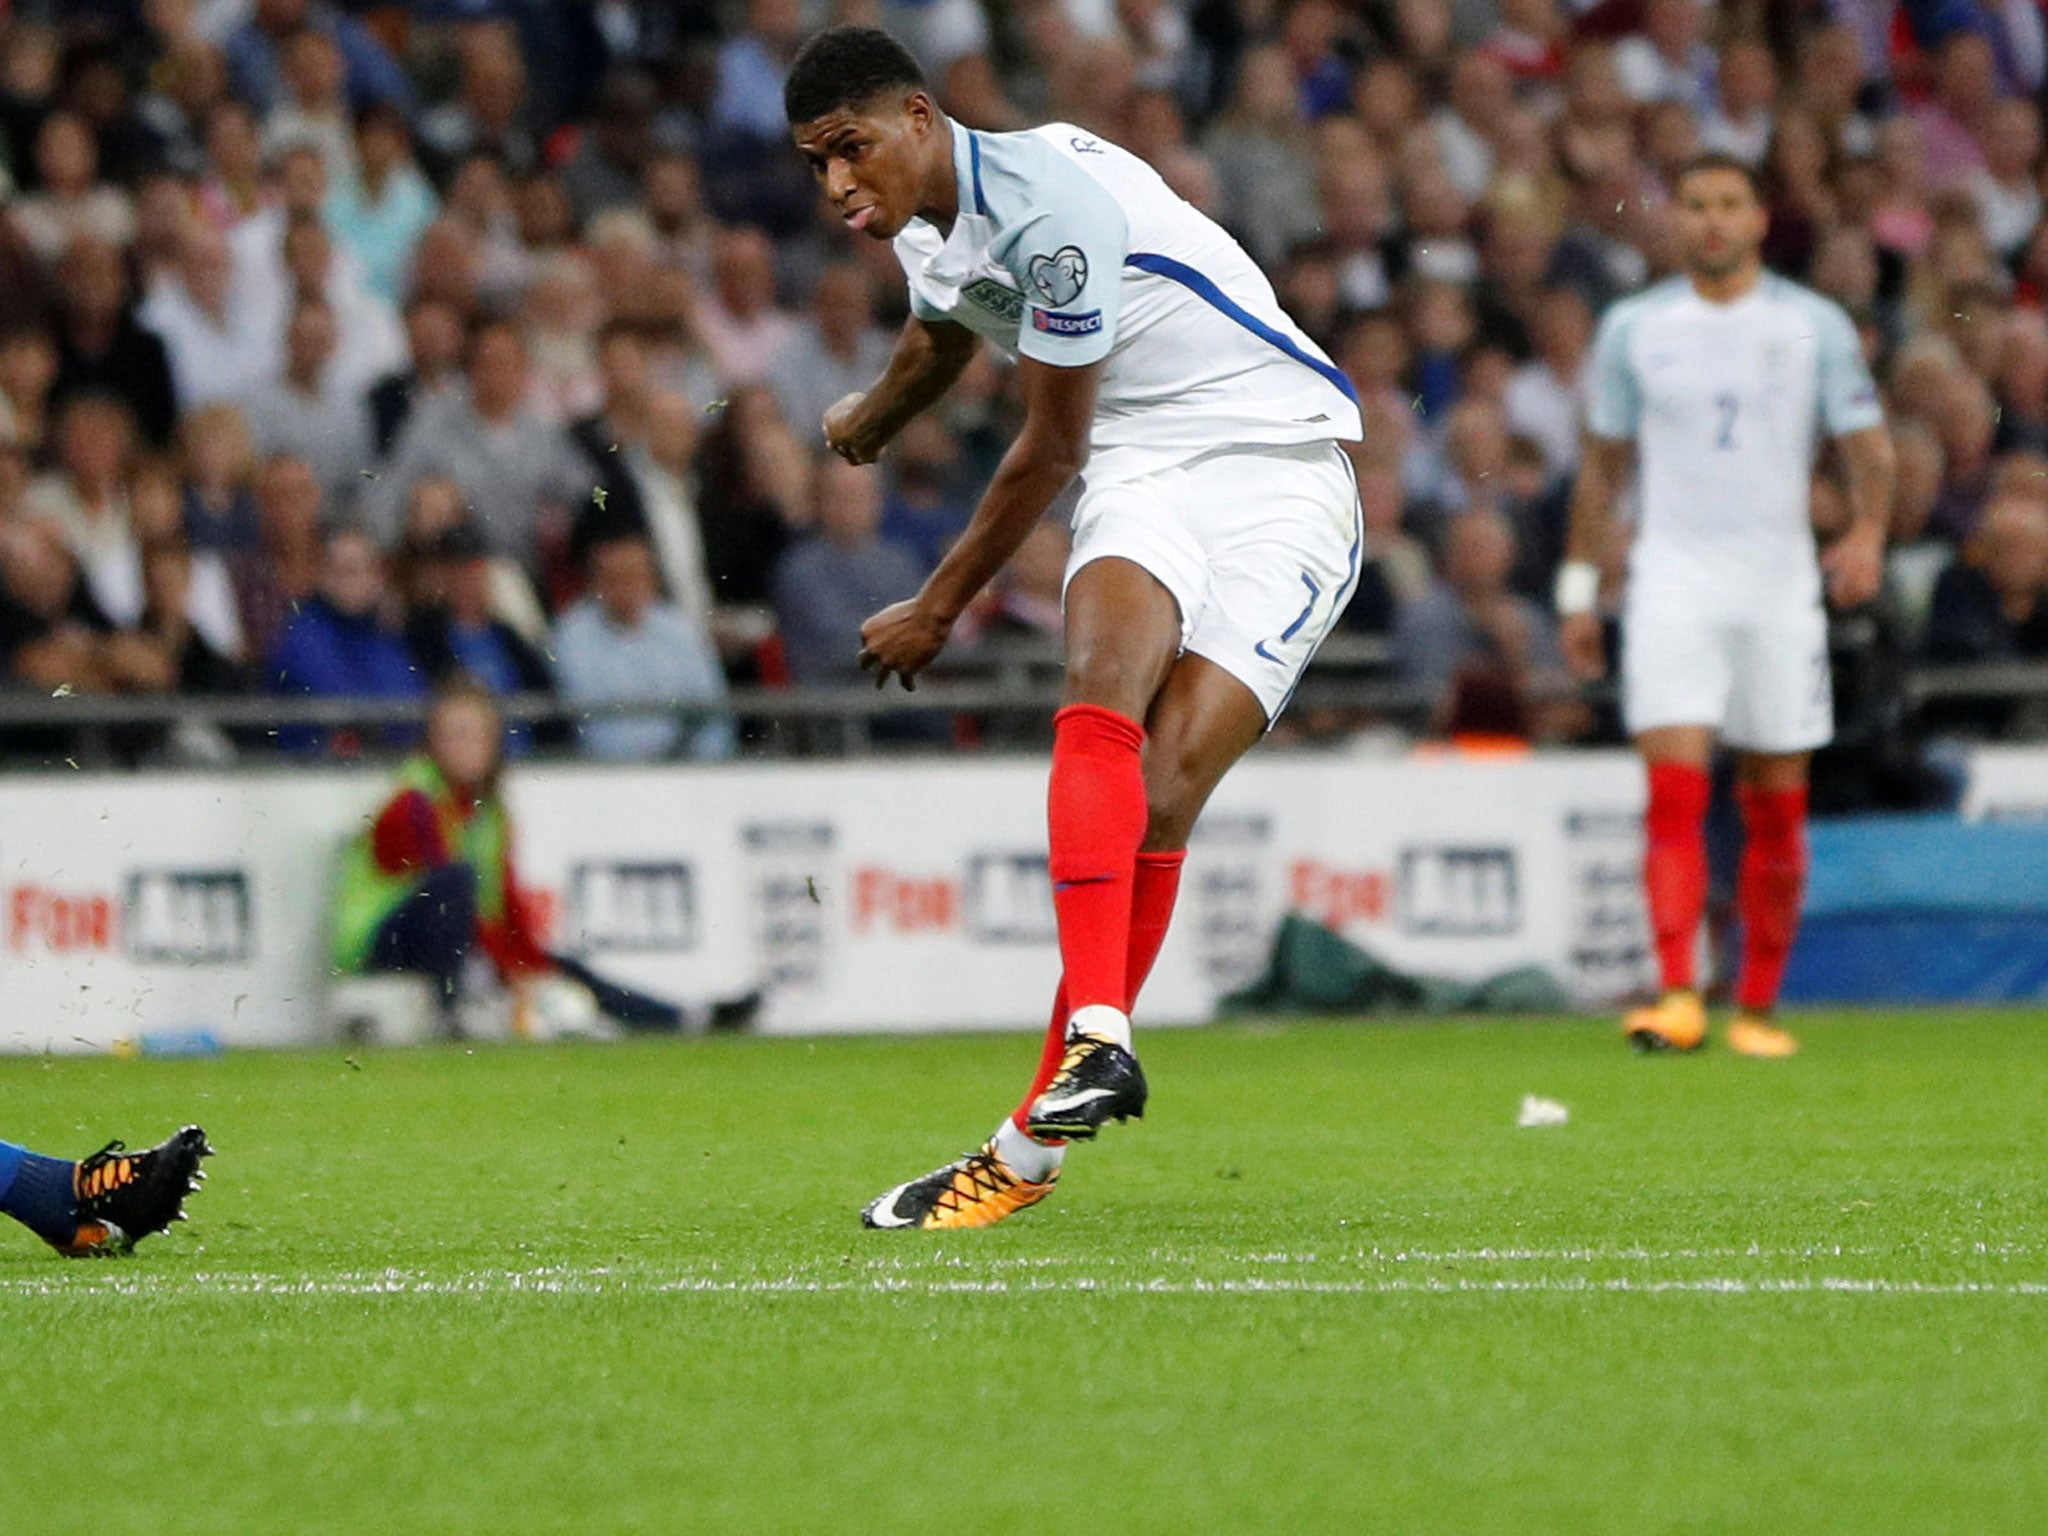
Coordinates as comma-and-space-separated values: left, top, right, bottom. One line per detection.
860, 358, 1102, 688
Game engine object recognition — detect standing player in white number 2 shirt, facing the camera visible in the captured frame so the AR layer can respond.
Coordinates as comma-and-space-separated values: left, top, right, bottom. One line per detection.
1556, 156, 1892, 1057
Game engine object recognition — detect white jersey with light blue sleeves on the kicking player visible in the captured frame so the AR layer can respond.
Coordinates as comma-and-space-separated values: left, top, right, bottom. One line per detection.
895, 123, 1362, 485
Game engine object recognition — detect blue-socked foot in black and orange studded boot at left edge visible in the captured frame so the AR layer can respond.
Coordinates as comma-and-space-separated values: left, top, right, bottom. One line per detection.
0, 1126, 213, 1257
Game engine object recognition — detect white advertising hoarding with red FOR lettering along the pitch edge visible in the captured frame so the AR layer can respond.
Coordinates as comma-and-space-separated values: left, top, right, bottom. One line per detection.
0, 754, 1645, 1051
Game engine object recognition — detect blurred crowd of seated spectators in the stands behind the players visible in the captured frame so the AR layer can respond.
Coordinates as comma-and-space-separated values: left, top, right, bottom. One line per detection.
0, 0, 2048, 758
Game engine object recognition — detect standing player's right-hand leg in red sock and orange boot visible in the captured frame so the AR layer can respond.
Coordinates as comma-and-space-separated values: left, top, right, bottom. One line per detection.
1729, 752, 1810, 1057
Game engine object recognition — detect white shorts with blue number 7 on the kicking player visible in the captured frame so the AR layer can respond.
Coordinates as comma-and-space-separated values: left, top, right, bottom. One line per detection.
1067, 440, 1364, 725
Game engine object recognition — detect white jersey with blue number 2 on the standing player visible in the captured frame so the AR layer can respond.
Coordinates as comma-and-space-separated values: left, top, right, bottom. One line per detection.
1587, 274, 1884, 612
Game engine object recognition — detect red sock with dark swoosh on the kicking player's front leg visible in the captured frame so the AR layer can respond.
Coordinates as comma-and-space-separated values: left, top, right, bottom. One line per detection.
1047, 705, 1145, 1012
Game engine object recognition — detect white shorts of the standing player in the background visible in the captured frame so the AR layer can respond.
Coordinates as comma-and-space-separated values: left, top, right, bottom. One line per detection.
1622, 600, 1835, 752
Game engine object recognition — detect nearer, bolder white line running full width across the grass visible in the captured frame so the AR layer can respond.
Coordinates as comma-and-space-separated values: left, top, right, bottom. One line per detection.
0, 1270, 2048, 1300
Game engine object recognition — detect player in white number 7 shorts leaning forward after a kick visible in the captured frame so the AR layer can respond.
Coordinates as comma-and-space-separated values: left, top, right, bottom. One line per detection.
784, 27, 1364, 1229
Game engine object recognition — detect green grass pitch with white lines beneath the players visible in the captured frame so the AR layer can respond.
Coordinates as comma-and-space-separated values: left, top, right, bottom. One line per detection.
0, 1014, 2048, 1536
